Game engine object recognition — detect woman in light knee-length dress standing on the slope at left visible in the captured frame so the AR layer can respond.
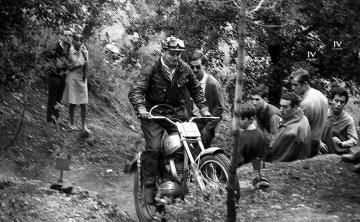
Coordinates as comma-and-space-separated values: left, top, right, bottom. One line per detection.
62, 34, 90, 135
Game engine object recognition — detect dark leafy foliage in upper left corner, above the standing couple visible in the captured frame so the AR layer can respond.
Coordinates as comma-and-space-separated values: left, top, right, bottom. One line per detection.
0, 0, 118, 89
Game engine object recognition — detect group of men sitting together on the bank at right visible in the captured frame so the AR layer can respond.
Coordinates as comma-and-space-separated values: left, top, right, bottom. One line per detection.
228, 69, 360, 172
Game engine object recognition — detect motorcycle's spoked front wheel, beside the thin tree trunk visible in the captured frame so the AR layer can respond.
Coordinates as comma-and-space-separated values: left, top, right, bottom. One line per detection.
199, 153, 230, 194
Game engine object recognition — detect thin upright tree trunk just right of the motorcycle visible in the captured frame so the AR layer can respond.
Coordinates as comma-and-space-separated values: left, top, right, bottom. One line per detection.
227, 0, 246, 222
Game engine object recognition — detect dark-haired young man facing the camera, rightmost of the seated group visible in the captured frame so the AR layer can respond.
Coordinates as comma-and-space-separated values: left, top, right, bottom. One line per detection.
321, 87, 358, 154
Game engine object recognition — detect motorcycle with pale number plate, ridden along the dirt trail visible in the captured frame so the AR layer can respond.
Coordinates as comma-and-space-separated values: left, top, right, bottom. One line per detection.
125, 105, 230, 222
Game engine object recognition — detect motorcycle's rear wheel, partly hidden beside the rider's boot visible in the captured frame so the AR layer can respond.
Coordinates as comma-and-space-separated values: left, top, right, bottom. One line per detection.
134, 169, 156, 222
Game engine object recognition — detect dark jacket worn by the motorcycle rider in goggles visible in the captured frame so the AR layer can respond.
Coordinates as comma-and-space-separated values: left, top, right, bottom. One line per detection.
129, 59, 207, 118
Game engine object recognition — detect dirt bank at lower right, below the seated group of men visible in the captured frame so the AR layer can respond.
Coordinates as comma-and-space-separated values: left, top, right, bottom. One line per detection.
238, 154, 360, 222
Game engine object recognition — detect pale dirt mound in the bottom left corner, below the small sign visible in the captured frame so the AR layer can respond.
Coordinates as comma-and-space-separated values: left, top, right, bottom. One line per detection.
0, 175, 130, 222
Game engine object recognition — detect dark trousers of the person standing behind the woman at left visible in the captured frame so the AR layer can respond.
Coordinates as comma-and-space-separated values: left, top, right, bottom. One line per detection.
46, 77, 65, 123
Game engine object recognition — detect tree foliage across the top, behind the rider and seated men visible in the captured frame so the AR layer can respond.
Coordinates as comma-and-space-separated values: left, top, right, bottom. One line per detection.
121, 0, 360, 104
